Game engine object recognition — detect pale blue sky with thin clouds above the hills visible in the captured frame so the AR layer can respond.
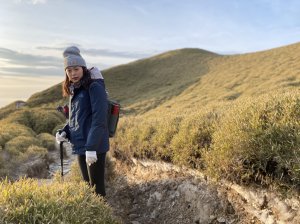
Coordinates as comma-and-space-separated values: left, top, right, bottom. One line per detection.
0, 0, 300, 107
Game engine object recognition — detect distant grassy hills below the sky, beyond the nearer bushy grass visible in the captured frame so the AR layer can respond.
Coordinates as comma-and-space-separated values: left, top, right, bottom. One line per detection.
4, 43, 300, 114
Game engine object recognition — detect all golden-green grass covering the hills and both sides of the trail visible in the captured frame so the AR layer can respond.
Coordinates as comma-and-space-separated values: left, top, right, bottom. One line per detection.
0, 44, 300, 223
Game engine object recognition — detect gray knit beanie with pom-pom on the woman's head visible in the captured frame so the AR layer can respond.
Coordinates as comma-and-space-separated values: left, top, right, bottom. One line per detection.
63, 46, 86, 70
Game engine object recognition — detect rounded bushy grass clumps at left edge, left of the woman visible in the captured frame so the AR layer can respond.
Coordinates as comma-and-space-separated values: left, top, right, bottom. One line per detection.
0, 120, 55, 177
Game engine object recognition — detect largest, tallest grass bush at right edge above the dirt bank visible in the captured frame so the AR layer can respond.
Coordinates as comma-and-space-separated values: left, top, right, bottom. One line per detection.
205, 92, 300, 187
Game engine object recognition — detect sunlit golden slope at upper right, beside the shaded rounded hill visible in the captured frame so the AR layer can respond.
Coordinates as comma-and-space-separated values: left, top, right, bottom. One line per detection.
150, 43, 300, 113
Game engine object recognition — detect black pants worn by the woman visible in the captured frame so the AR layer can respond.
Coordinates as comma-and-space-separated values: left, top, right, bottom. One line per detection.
77, 153, 106, 197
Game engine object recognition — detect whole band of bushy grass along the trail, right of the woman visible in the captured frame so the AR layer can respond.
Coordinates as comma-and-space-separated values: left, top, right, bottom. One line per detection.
112, 91, 300, 191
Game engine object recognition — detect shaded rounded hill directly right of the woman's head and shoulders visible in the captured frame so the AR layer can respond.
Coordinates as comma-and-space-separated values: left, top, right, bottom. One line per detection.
103, 49, 220, 112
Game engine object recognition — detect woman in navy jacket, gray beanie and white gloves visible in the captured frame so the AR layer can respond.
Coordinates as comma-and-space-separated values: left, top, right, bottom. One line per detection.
56, 46, 109, 196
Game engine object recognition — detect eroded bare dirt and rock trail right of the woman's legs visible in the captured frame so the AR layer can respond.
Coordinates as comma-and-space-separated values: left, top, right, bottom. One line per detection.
107, 160, 300, 224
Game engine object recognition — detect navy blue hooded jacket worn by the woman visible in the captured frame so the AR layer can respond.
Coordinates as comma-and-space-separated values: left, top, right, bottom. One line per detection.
63, 79, 109, 155
